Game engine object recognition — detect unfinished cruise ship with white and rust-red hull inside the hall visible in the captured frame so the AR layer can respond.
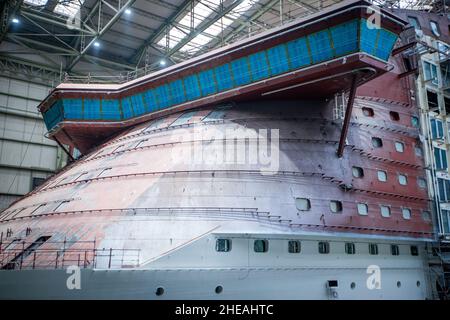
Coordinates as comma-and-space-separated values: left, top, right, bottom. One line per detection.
0, 0, 450, 300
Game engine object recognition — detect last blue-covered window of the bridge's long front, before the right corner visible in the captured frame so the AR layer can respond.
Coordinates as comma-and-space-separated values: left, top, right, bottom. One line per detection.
330, 20, 358, 56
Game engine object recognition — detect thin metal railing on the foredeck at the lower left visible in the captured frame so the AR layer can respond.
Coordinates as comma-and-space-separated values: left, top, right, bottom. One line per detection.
0, 239, 140, 270
